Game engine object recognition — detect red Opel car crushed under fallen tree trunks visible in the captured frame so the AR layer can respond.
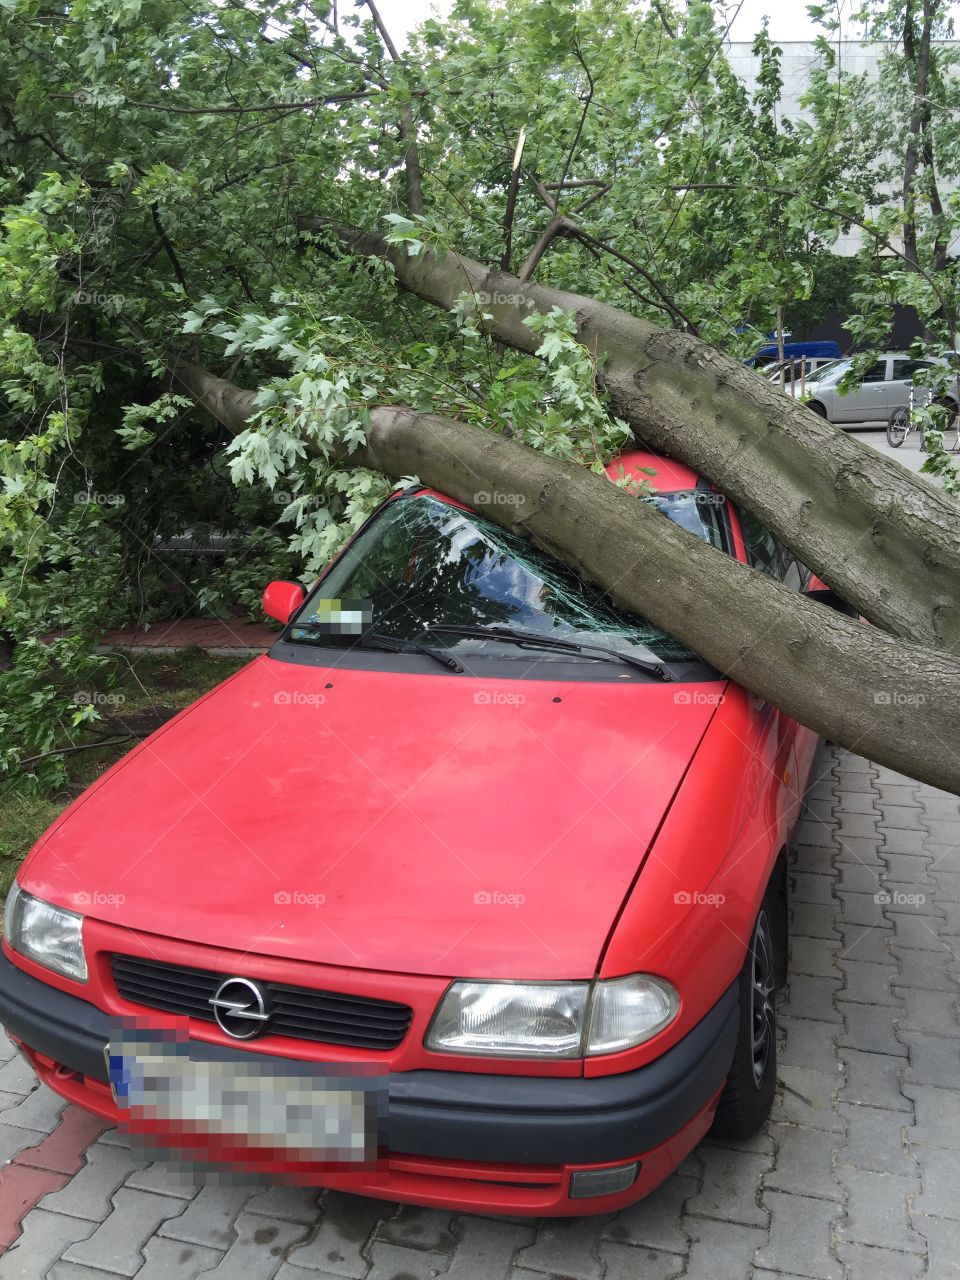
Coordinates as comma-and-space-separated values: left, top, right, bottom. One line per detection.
0, 452, 819, 1215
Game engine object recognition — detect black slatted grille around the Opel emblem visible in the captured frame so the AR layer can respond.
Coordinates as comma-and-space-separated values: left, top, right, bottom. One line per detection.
110, 955, 413, 1048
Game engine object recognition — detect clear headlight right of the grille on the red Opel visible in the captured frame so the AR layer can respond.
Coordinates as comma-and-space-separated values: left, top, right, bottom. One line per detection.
426, 974, 680, 1059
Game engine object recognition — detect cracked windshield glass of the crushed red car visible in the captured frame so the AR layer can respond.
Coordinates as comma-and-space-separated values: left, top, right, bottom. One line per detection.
288, 495, 717, 662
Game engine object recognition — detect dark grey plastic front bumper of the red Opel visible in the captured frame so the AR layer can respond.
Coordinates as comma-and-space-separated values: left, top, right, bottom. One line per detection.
0, 952, 737, 1212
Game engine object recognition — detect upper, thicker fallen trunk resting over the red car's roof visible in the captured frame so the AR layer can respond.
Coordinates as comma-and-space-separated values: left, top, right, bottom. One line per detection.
301, 219, 960, 650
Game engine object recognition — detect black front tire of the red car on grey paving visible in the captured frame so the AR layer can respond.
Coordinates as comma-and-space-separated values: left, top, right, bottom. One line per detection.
710, 886, 778, 1142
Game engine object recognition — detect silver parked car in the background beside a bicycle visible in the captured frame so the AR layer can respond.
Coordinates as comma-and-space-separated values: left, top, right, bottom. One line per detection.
785, 351, 957, 426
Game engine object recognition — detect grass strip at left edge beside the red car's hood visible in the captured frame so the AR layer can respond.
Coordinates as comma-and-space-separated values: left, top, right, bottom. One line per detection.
0, 649, 250, 901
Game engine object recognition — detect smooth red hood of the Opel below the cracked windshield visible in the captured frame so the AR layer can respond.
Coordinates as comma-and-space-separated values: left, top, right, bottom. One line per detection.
20, 657, 718, 978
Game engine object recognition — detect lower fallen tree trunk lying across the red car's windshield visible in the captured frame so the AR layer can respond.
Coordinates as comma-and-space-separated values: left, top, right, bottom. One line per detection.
177, 364, 960, 794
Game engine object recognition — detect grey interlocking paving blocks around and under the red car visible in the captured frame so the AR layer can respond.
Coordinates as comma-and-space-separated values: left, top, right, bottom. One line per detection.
0, 749, 960, 1280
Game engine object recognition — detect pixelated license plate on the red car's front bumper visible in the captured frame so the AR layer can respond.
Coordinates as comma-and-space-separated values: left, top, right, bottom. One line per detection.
105, 1038, 387, 1165
